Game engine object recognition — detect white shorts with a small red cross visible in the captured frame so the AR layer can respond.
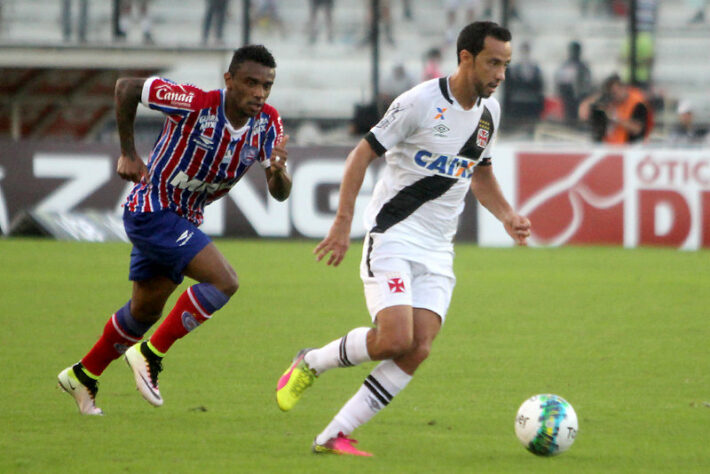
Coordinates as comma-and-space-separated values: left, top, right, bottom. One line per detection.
360, 234, 456, 324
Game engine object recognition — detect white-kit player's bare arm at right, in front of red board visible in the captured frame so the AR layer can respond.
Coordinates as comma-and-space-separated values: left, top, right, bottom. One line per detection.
471, 166, 530, 245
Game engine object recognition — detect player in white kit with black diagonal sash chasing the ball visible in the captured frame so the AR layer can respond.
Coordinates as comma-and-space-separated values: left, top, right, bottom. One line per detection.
276, 22, 530, 456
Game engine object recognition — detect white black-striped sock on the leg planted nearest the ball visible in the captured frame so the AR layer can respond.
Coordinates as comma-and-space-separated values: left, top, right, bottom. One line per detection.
316, 359, 412, 444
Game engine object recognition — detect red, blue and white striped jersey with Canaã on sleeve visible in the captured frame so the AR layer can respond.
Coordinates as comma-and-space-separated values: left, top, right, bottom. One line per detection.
125, 77, 283, 225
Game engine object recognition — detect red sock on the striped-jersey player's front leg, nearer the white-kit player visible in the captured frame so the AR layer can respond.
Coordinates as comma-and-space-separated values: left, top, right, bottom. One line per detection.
150, 287, 211, 356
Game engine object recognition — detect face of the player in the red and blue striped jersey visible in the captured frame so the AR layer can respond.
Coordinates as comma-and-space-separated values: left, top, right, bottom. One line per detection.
224, 61, 276, 117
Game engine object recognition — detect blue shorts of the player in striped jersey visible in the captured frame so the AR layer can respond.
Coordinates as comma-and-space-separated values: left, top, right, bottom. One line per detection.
123, 209, 211, 284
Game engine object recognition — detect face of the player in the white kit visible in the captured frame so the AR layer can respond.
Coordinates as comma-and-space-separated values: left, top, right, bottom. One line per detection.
471, 36, 513, 98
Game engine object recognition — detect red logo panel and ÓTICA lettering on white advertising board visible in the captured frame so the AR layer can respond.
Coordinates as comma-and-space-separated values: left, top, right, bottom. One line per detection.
517, 149, 710, 249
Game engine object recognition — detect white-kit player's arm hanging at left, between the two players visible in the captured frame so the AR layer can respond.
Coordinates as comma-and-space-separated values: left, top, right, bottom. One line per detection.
313, 139, 378, 266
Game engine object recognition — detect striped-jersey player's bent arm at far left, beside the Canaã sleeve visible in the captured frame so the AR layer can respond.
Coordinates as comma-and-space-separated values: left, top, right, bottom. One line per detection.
114, 77, 148, 182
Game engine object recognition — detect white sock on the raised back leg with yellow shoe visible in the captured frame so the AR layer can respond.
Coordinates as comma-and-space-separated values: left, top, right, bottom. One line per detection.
305, 328, 372, 375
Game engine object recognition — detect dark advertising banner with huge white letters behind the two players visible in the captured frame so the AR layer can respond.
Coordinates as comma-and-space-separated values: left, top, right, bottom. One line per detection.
0, 137, 476, 241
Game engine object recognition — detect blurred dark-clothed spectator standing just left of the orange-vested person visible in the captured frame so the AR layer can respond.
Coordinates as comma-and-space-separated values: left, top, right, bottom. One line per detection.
555, 41, 592, 124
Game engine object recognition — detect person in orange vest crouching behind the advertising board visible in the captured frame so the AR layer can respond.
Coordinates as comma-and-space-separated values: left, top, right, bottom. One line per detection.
579, 74, 653, 145
